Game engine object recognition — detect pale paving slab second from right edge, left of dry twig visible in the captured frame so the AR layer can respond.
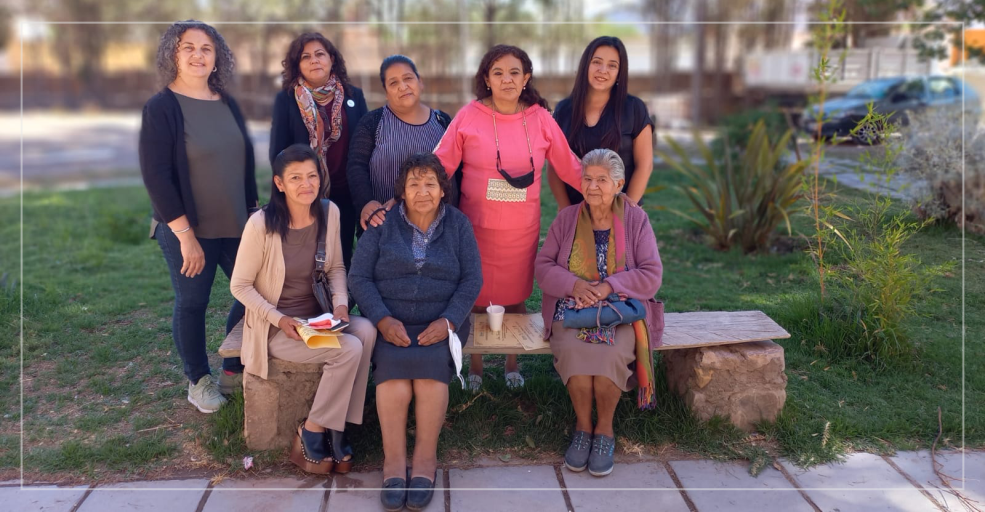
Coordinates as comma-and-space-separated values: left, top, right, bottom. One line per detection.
781, 453, 938, 512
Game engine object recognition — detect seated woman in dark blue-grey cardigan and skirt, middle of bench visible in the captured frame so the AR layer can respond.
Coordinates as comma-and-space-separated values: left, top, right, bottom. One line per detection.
349, 153, 482, 510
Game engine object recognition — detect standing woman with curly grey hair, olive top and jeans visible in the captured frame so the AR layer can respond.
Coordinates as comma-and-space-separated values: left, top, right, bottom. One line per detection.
139, 20, 257, 413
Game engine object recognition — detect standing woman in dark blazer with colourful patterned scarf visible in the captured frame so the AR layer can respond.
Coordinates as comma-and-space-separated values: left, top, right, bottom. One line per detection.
270, 32, 368, 270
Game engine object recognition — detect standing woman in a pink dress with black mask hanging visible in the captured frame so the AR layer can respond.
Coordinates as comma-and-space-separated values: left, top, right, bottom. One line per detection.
434, 45, 581, 392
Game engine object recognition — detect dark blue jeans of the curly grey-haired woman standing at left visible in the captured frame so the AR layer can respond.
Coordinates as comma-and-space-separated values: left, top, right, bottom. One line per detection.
154, 222, 246, 383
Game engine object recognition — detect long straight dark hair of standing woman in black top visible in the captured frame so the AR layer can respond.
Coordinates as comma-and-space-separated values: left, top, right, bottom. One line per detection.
565, 36, 629, 152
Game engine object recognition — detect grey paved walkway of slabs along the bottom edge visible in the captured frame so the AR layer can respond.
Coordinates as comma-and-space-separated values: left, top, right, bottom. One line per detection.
0, 451, 985, 512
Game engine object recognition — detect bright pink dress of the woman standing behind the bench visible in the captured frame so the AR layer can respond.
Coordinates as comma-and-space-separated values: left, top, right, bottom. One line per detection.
434, 101, 581, 306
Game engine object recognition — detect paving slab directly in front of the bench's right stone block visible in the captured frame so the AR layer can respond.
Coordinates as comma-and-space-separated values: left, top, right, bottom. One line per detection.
670, 460, 813, 512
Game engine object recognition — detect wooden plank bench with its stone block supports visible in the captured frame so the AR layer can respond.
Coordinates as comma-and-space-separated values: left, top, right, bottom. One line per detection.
219, 311, 790, 450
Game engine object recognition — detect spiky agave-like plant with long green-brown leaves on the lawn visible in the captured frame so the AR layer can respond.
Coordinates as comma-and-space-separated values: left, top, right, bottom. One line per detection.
657, 120, 807, 253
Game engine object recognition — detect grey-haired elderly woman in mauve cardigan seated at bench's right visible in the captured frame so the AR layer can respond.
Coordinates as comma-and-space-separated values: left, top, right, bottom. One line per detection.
535, 149, 663, 476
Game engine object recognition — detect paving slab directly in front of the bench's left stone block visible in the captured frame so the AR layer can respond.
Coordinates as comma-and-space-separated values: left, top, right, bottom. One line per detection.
202, 477, 328, 512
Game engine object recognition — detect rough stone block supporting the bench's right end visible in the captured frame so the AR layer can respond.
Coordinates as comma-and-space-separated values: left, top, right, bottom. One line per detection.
663, 341, 787, 431
